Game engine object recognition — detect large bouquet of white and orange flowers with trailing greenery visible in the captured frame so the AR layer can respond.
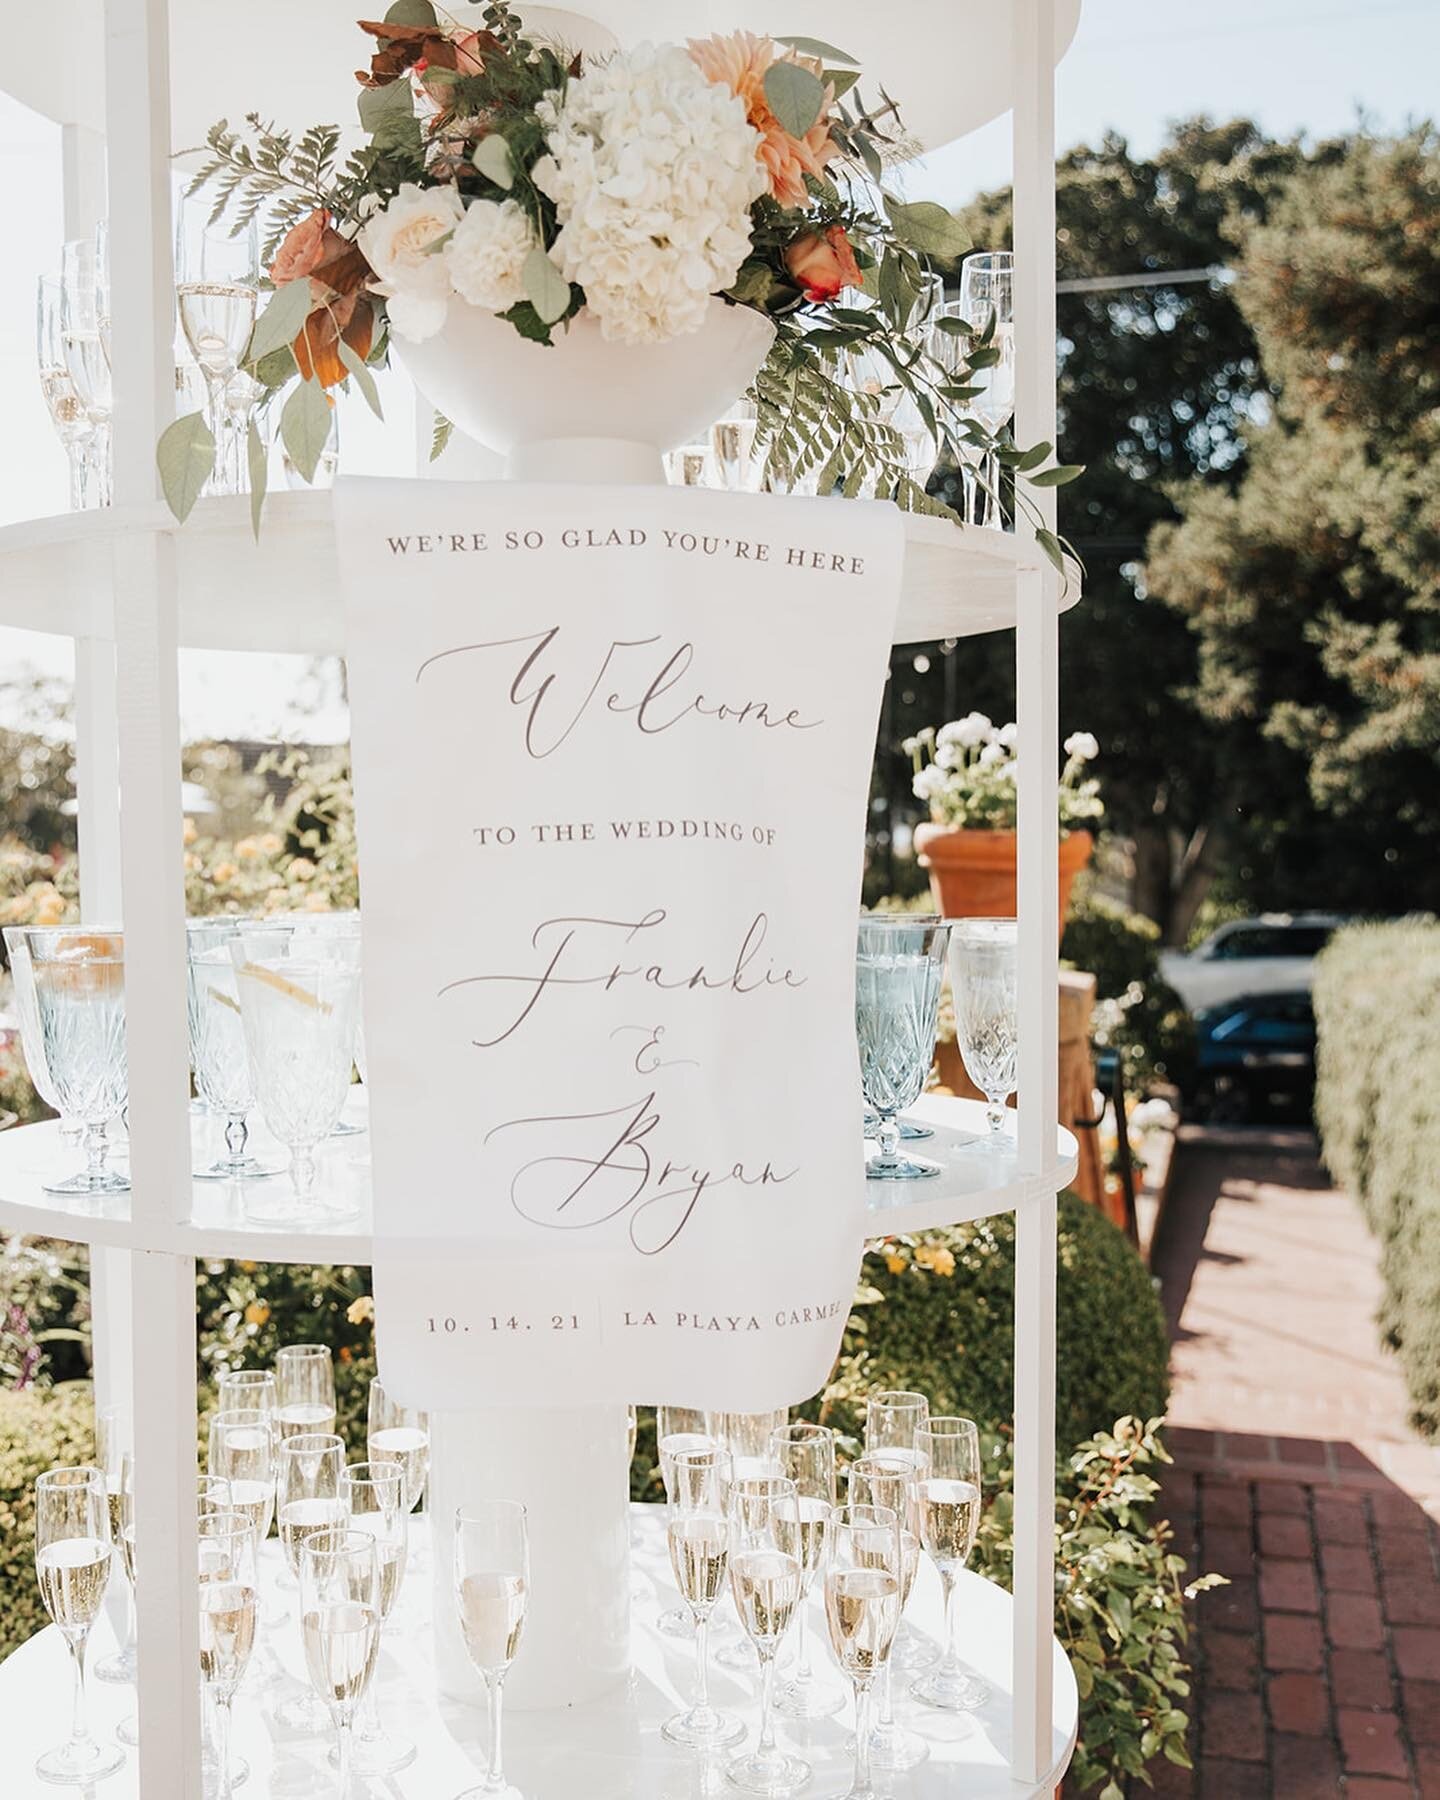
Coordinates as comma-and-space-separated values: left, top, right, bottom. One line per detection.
158, 0, 1080, 540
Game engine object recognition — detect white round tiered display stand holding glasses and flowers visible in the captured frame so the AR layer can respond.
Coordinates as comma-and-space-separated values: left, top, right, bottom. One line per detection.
0, 0, 1078, 1800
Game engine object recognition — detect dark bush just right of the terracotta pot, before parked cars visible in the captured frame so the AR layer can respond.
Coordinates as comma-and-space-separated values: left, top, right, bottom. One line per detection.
1060, 877, 1195, 1094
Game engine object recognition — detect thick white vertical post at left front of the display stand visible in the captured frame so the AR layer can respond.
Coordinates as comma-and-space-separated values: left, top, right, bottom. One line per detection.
104, 0, 202, 1800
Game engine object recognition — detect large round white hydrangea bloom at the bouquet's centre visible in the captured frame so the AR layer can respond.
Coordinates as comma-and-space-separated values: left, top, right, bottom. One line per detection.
533, 45, 767, 344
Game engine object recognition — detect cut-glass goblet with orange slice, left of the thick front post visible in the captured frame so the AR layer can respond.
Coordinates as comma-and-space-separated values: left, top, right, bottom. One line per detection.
25, 925, 130, 1197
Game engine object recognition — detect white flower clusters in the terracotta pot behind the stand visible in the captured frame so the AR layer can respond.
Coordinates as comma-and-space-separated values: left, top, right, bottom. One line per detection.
904, 713, 1105, 832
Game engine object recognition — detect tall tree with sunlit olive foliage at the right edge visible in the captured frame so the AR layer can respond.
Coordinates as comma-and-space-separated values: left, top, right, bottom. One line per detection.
1147, 128, 1440, 911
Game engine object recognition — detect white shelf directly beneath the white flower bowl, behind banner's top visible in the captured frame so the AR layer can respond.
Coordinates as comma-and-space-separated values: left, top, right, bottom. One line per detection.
0, 490, 1080, 655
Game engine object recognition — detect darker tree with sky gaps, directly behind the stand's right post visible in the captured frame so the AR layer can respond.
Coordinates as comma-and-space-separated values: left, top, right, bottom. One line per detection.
891, 119, 1337, 938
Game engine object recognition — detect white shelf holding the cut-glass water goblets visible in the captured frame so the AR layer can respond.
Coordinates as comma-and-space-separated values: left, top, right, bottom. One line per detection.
0, 1091, 1076, 1264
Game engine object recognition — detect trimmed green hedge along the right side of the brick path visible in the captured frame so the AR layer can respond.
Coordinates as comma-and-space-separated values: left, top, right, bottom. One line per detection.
1314, 920, 1440, 1438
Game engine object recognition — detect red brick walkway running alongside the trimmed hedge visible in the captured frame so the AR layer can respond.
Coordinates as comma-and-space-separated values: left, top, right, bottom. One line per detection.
1136, 1129, 1440, 1800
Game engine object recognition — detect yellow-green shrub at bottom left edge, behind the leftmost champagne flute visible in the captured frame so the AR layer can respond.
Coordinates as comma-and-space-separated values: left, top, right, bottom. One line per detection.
0, 1382, 95, 1658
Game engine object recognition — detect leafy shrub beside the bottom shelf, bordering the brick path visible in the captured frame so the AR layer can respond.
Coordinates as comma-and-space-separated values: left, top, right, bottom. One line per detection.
972, 1418, 1222, 1800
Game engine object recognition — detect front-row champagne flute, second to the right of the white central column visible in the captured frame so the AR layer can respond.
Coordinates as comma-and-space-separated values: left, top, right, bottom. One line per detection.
725, 1474, 810, 1796
